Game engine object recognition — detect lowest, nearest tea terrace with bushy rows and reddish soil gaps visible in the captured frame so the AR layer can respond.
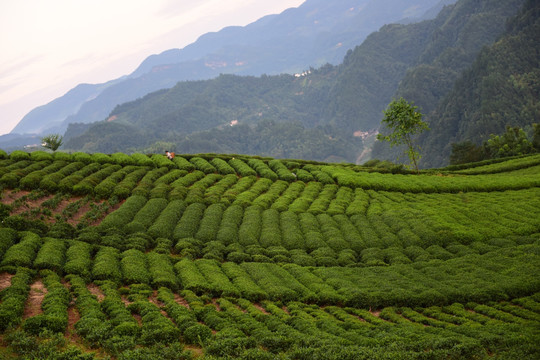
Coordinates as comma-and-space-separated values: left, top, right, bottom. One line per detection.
0, 268, 540, 359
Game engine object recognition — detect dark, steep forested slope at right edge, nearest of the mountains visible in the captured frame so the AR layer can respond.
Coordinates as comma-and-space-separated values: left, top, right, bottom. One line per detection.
421, 1, 540, 167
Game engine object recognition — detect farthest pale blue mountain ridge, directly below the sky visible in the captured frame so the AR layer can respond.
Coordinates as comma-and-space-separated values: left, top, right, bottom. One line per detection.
12, 0, 449, 139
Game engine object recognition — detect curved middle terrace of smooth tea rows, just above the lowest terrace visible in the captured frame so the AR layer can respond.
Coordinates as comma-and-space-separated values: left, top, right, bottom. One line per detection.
0, 229, 540, 308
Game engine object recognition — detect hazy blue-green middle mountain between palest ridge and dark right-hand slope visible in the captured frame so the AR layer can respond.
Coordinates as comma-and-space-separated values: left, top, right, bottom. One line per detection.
66, 0, 522, 162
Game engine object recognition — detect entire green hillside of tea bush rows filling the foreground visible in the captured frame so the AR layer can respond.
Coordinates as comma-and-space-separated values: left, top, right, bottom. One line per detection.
0, 151, 540, 360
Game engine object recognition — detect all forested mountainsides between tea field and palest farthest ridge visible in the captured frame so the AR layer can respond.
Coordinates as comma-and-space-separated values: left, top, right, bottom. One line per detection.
64, 0, 540, 168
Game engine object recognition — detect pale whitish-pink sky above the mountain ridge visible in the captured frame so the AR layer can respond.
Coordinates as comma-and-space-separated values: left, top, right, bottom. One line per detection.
0, 0, 304, 135
